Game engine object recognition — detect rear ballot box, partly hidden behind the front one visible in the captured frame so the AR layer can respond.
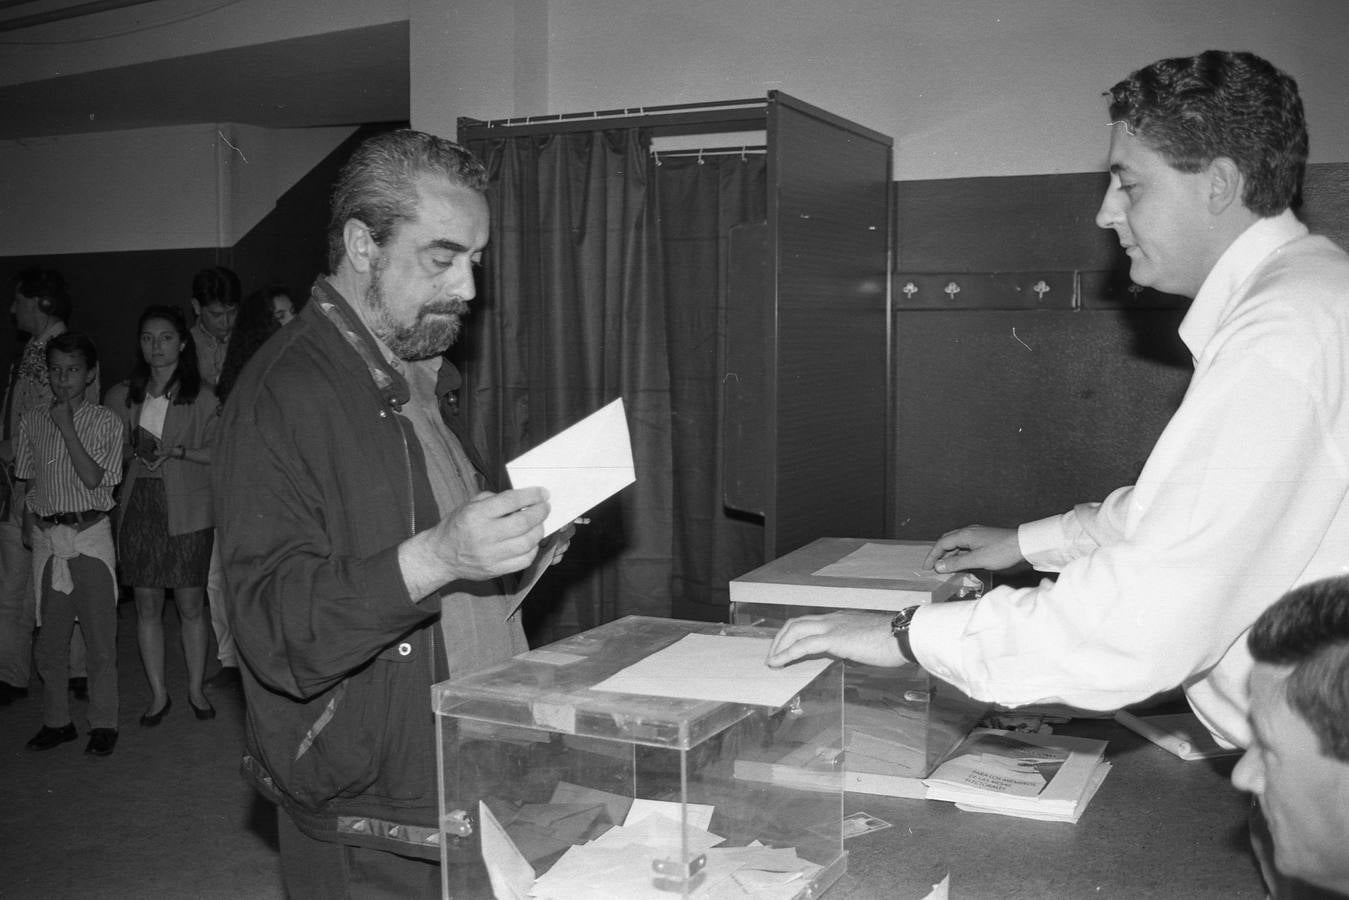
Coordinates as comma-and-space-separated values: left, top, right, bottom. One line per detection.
730, 537, 990, 797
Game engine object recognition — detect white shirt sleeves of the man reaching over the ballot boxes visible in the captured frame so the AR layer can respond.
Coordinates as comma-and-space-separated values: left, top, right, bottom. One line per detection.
911, 321, 1349, 710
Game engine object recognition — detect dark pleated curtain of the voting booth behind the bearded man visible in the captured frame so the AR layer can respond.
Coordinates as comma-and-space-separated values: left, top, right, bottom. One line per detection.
456, 130, 762, 644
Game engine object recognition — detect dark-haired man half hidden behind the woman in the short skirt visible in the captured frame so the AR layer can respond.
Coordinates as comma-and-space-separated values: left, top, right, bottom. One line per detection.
192, 266, 243, 687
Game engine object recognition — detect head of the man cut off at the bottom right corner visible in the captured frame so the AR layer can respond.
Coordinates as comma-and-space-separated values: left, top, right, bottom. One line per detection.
1232, 576, 1349, 900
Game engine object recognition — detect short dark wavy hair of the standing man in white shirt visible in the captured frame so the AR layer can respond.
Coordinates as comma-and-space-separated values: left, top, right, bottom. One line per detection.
1109, 50, 1307, 216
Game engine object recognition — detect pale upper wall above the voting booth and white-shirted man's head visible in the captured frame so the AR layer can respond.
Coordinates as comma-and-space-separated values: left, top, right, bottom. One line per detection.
410, 0, 1349, 179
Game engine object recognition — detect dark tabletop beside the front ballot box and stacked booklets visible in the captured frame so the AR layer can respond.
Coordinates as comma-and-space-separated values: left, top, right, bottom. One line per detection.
824, 719, 1265, 900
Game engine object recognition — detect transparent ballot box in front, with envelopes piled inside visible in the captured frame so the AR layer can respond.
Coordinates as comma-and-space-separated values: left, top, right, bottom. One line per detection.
432, 617, 846, 900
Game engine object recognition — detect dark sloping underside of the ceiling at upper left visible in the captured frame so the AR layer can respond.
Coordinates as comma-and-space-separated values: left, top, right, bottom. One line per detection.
0, 22, 410, 139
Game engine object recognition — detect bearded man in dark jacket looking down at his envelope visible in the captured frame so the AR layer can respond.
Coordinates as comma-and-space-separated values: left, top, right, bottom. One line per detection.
213, 131, 565, 900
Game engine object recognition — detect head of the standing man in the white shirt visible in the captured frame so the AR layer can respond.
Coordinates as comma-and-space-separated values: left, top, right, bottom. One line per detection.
1097, 50, 1307, 297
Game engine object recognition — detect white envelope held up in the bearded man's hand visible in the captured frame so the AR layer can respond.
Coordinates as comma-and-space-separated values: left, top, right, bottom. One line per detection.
506, 398, 637, 534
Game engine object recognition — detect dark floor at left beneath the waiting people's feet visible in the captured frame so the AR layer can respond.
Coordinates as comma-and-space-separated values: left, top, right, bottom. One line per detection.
0, 602, 285, 900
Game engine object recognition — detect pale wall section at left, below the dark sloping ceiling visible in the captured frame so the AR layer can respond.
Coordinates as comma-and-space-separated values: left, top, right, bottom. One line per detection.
0, 124, 352, 256
